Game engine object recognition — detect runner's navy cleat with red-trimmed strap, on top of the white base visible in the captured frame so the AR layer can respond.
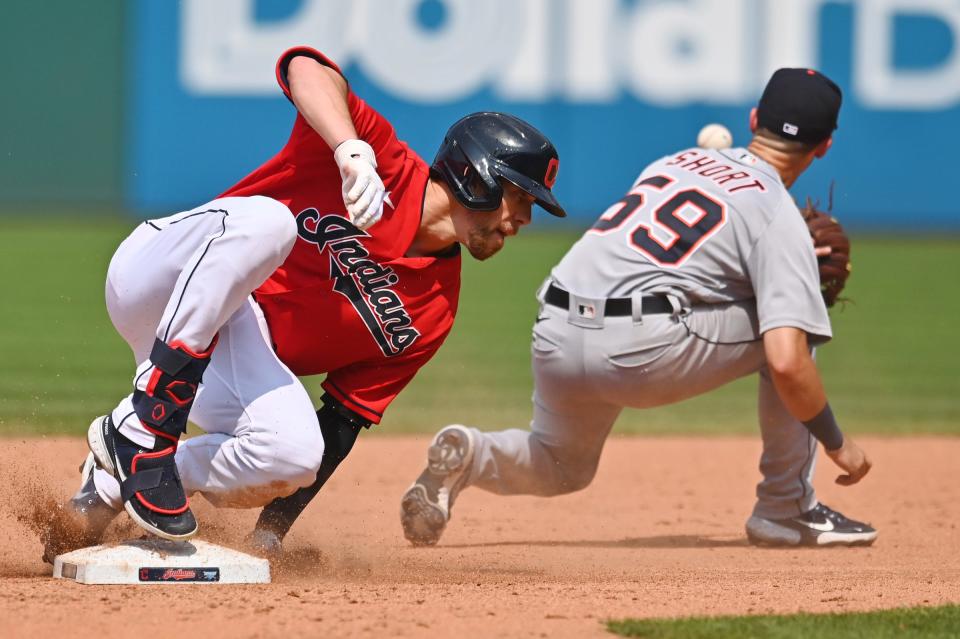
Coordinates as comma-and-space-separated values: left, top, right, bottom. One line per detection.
87, 415, 198, 541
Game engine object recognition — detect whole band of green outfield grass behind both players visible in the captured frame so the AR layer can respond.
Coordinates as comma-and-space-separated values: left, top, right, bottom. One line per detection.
0, 217, 960, 435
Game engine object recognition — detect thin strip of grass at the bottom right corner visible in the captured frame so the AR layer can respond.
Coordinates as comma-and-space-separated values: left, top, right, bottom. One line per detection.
607, 606, 960, 639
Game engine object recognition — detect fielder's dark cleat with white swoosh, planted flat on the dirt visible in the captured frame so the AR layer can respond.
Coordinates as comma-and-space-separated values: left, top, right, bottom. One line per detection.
747, 504, 877, 546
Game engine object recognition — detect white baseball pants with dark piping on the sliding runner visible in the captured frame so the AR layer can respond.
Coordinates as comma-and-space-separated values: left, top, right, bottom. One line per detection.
94, 196, 323, 508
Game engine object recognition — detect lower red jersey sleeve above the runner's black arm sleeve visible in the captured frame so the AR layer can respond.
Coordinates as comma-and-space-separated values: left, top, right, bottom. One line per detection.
321, 340, 442, 424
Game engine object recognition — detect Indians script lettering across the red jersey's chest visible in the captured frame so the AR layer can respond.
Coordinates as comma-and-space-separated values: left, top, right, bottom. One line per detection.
297, 208, 420, 357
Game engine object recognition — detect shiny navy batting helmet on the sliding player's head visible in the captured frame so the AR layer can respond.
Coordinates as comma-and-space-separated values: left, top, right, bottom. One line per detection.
430, 112, 567, 217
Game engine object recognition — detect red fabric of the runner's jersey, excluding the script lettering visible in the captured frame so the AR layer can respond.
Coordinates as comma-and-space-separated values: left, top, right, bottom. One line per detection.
223, 47, 460, 423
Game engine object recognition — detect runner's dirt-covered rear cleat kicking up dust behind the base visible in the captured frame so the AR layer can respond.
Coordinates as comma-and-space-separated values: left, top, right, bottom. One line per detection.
41, 453, 120, 564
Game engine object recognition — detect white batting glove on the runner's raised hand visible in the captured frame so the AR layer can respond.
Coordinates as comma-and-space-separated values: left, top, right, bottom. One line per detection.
333, 140, 384, 229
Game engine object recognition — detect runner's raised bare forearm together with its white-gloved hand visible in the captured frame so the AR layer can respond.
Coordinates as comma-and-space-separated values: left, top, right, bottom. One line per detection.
287, 56, 384, 229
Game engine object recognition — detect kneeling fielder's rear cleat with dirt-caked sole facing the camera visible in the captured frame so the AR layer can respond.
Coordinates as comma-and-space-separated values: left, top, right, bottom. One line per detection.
400, 425, 475, 546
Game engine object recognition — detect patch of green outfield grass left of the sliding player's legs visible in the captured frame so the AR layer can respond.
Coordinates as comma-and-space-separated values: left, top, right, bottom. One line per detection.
0, 217, 133, 434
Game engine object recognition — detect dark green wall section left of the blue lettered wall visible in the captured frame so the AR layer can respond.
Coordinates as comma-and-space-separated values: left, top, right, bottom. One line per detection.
0, 0, 125, 212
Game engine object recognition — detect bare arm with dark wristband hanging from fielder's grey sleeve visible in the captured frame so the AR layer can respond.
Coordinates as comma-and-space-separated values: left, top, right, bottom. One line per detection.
763, 327, 872, 486
